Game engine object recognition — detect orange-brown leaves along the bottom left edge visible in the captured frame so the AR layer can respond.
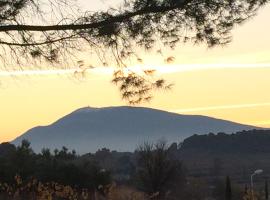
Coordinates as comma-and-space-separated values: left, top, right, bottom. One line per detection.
0, 175, 148, 200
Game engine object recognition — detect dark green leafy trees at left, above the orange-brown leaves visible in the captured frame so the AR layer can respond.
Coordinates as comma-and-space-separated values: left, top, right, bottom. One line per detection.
0, 141, 111, 190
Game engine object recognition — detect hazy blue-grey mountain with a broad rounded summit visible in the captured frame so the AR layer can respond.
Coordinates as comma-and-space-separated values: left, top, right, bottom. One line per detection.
12, 107, 256, 153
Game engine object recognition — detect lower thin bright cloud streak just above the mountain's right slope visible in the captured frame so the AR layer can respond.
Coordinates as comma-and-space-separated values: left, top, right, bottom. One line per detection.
172, 102, 270, 113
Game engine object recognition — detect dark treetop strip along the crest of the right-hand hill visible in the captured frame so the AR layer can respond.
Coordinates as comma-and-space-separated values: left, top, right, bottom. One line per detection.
181, 130, 270, 154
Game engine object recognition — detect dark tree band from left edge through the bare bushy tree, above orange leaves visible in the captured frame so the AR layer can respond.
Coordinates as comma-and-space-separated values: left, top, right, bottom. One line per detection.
0, 140, 189, 199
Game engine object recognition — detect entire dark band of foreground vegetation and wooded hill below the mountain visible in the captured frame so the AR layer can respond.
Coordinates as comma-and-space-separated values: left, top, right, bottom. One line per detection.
0, 130, 270, 200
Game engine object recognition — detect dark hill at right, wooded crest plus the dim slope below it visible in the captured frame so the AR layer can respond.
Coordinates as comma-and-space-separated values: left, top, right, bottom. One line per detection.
177, 130, 270, 183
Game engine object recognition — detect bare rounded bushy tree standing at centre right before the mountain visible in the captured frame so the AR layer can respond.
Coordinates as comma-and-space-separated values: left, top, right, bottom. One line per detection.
137, 141, 185, 199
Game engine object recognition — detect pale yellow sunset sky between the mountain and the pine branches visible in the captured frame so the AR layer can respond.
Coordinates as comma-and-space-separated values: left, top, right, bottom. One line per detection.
0, 0, 270, 142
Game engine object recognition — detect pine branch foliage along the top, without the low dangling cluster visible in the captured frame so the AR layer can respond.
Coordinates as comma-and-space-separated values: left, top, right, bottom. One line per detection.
0, 0, 268, 61
